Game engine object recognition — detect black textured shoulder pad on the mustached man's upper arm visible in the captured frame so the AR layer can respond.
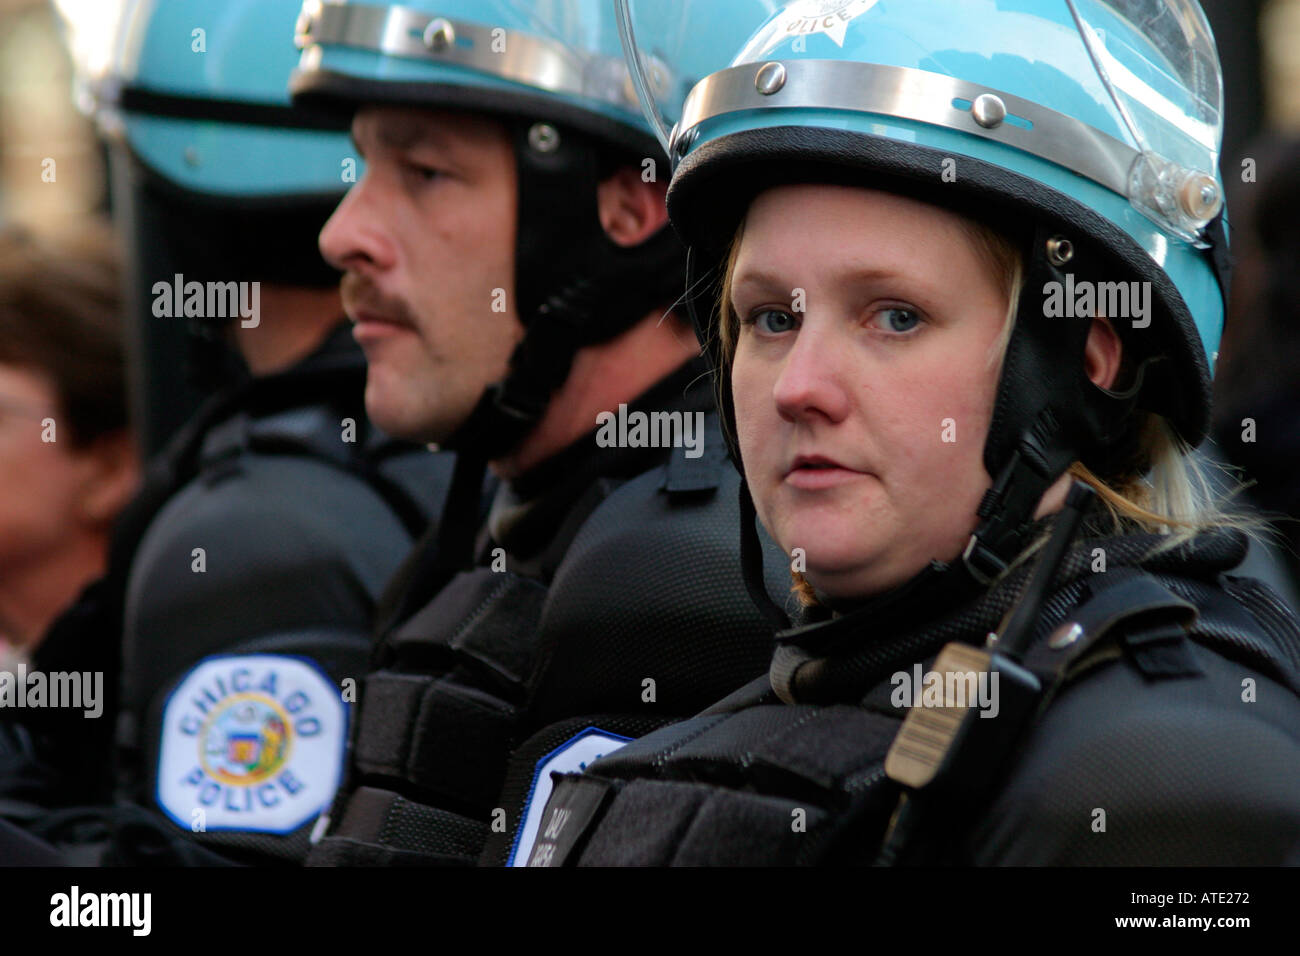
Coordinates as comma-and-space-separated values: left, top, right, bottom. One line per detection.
522, 457, 789, 724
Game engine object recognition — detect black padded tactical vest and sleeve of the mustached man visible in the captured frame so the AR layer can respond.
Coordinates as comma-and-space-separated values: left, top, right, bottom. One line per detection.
308, 365, 789, 865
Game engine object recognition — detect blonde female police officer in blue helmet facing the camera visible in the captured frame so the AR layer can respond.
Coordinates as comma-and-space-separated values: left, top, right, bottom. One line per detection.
520, 0, 1300, 865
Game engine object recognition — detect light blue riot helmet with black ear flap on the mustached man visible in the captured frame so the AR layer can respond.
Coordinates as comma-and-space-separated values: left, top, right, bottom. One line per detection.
294, 0, 775, 458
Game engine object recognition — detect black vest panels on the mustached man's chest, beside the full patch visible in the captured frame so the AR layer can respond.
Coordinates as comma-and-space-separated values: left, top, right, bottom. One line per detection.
354, 568, 546, 810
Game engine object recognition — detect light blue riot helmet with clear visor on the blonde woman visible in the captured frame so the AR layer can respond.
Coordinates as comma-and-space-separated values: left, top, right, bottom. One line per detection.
618, 0, 1227, 598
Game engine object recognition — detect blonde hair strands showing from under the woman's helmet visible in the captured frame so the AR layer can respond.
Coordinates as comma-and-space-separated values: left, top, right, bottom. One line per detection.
714, 208, 1269, 606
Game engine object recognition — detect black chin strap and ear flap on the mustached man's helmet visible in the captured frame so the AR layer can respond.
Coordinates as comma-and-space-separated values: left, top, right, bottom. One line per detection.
428, 122, 684, 579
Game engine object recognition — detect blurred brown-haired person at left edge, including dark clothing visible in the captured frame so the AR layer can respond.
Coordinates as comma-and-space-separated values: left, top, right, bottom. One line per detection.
0, 221, 139, 853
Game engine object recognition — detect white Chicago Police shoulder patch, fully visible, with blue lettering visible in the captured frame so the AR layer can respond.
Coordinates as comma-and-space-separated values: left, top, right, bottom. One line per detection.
157, 654, 347, 834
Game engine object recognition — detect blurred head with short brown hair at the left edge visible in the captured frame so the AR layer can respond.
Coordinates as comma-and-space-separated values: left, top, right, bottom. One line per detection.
0, 224, 139, 670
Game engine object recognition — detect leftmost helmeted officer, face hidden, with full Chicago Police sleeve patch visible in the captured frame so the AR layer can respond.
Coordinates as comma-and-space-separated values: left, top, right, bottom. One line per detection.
6, 0, 450, 862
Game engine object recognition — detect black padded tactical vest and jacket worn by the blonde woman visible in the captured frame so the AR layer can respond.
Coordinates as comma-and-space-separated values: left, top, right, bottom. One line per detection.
529, 522, 1300, 866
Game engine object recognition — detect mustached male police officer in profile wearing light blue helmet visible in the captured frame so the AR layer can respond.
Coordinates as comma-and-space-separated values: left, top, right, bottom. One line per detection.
294, 0, 785, 864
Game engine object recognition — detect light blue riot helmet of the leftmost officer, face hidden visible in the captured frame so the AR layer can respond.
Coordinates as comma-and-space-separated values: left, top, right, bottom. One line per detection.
74, 0, 359, 451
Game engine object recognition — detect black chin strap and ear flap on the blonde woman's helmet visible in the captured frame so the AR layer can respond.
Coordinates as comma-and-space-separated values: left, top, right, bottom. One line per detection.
737, 222, 1140, 650
